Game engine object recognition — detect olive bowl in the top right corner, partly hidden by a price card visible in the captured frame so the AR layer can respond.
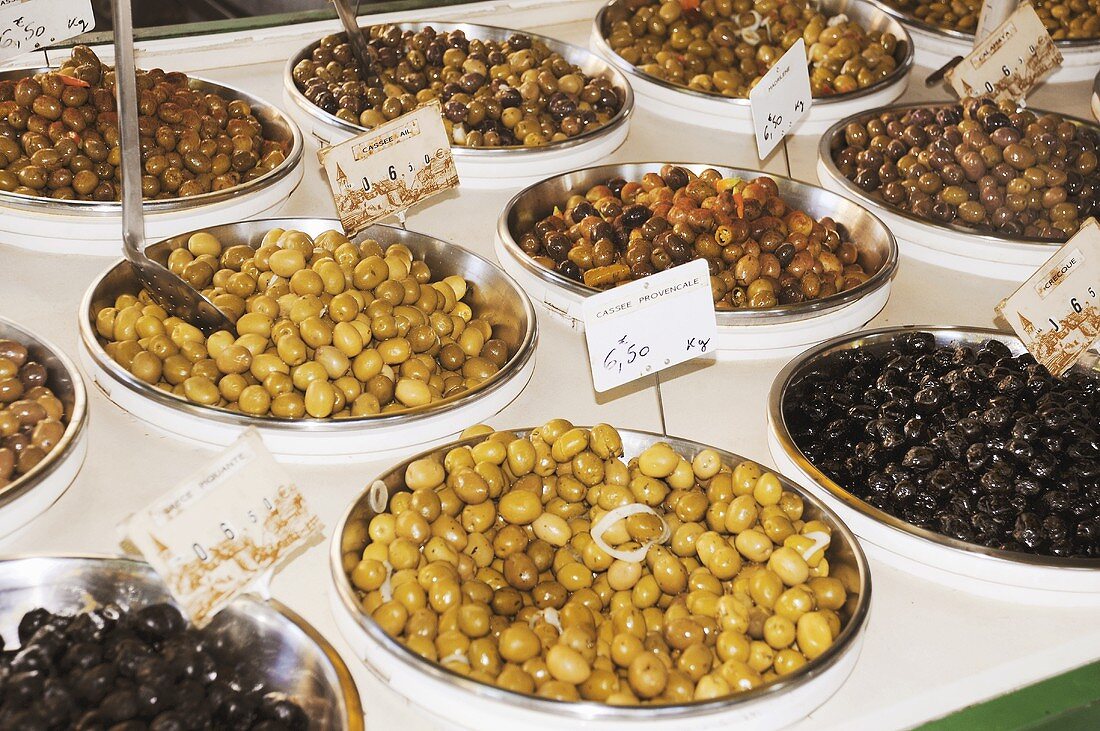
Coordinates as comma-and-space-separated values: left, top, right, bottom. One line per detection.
871, 0, 1100, 81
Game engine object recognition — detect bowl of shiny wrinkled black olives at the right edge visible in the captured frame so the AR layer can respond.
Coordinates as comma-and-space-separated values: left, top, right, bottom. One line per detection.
769, 326, 1100, 605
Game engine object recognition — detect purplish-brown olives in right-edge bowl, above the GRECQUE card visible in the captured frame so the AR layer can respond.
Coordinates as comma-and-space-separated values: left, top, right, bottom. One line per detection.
832, 99, 1100, 241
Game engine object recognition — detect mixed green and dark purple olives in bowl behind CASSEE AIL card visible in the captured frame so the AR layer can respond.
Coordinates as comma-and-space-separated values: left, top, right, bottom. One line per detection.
293, 25, 624, 147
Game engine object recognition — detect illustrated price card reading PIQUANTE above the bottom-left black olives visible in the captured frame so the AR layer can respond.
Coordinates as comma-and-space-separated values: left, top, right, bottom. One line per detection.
120, 429, 321, 627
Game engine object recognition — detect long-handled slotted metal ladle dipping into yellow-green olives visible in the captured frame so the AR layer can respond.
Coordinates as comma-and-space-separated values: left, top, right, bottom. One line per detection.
111, 0, 237, 334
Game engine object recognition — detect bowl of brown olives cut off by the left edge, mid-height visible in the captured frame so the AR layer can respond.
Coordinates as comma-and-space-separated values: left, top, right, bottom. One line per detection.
0, 318, 88, 536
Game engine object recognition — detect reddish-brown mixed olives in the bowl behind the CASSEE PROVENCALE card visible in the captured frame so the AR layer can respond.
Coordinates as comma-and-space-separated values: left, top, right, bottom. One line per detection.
519, 165, 873, 310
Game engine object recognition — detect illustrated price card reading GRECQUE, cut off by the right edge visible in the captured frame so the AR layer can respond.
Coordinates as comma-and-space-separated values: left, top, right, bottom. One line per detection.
997, 219, 1100, 376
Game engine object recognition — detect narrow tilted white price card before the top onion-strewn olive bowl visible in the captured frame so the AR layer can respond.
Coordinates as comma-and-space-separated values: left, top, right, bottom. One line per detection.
749, 38, 812, 159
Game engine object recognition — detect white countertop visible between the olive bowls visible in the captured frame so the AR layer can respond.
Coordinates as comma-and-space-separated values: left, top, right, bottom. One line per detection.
0, 2, 1100, 731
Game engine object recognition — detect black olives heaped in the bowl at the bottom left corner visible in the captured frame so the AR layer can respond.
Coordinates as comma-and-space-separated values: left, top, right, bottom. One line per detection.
0, 605, 310, 731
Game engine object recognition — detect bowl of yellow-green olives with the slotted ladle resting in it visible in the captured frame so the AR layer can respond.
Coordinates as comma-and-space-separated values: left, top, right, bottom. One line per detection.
79, 214, 538, 461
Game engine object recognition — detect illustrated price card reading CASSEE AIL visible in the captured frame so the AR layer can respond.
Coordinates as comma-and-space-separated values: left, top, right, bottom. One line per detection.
318, 100, 459, 236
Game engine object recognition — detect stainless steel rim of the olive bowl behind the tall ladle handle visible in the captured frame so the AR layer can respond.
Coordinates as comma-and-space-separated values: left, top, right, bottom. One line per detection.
0, 67, 303, 217
